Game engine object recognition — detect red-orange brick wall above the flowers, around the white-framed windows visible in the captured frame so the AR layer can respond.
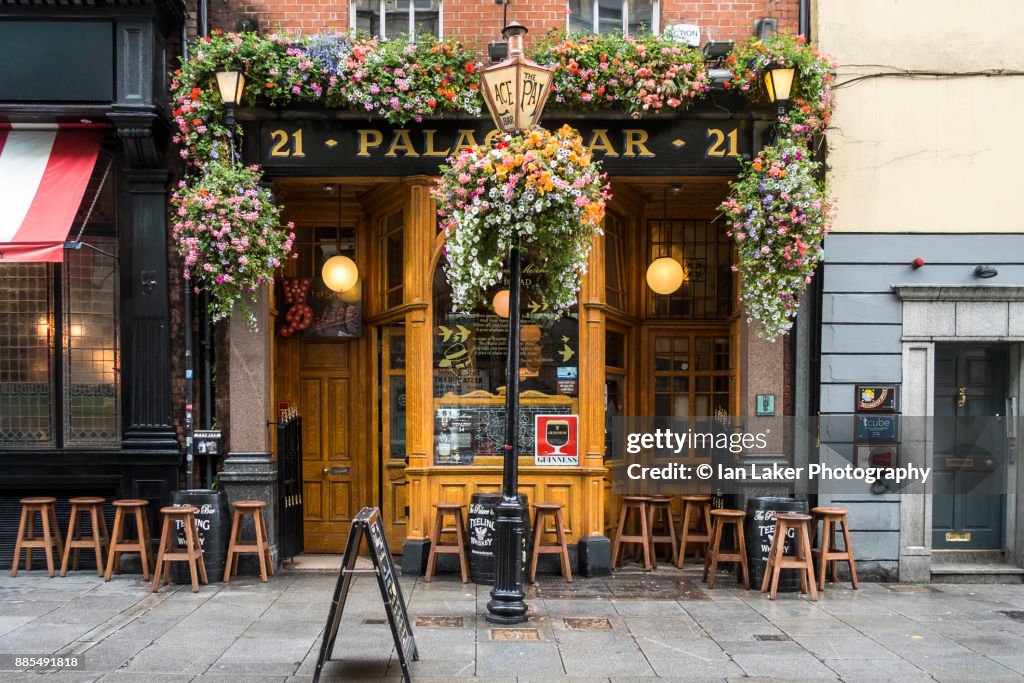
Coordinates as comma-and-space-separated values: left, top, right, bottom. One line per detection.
188, 0, 799, 44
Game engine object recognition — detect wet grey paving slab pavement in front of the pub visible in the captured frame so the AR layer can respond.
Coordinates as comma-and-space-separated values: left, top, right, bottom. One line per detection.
0, 567, 1024, 683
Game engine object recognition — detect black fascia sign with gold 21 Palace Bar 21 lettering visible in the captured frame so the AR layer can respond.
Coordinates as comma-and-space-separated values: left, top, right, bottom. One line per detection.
246, 119, 753, 175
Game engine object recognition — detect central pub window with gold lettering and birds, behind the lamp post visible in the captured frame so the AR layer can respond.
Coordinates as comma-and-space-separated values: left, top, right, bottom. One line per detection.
433, 259, 580, 465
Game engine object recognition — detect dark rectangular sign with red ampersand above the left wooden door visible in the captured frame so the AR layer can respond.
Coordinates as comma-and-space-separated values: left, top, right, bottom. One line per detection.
278, 278, 362, 338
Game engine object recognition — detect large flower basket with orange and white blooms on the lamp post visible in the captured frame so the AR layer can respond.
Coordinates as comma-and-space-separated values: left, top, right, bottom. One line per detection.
434, 126, 609, 312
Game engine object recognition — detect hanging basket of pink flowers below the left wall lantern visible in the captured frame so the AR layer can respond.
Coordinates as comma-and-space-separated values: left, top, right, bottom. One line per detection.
171, 162, 295, 327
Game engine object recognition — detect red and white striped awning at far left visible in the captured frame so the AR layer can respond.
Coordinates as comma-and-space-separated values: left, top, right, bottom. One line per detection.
0, 123, 103, 263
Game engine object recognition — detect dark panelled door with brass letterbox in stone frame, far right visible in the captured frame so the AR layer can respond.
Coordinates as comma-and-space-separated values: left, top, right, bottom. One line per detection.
932, 344, 1008, 550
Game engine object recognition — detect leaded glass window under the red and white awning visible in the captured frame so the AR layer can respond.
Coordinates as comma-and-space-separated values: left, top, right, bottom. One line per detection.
0, 156, 121, 447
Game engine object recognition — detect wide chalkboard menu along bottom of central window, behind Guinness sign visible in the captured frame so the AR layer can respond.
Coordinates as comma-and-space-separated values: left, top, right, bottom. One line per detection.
434, 404, 572, 465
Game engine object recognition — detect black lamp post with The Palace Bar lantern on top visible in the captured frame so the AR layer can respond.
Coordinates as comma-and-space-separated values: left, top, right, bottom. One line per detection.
480, 22, 552, 624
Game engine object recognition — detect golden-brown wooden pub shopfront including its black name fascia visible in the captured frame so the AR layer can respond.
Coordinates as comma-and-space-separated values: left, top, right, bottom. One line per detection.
246, 110, 781, 572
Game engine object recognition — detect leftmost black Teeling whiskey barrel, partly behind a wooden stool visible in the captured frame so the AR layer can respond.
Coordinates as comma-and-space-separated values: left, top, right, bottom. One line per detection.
169, 488, 231, 584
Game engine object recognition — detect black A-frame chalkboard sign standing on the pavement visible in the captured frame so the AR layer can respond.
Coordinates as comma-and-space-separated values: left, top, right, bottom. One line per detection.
313, 508, 419, 683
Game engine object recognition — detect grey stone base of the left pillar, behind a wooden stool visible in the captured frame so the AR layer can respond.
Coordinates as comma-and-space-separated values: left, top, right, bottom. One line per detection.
218, 453, 280, 574
